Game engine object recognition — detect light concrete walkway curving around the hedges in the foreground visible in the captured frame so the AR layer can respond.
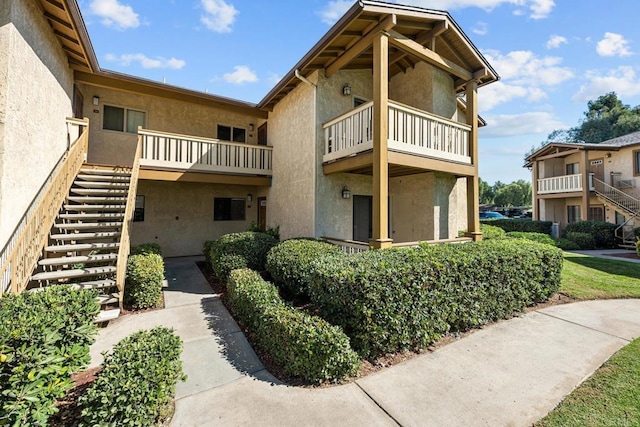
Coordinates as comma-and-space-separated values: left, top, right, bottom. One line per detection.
91, 258, 640, 427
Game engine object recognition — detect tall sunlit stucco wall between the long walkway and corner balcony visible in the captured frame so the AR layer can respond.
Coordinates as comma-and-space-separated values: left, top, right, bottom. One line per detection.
267, 73, 318, 239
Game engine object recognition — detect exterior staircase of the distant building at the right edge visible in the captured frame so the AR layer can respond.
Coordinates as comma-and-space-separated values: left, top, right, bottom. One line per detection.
593, 178, 640, 250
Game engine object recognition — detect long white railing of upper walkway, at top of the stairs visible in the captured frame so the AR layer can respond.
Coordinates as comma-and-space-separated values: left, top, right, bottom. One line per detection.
138, 129, 273, 175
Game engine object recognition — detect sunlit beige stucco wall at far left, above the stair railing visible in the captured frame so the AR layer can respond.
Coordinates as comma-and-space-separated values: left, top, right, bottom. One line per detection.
0, 0, 73, 247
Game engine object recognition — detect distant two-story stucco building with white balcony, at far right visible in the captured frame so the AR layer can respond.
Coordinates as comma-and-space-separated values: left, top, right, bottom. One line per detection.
525, 132, 640, 244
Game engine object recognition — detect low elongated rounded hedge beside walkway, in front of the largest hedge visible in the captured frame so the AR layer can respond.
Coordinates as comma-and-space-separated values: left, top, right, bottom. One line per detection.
227, 269, 359, 383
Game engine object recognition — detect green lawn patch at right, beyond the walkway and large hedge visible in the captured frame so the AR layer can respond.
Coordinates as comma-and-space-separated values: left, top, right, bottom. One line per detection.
560, 252, 640, 300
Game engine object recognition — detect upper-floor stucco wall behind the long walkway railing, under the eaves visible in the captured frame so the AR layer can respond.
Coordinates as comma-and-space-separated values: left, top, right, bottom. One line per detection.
78, 84, 265, 166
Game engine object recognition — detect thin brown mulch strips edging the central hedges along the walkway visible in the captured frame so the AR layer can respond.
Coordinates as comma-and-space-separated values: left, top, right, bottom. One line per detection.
196, 261, 577, 388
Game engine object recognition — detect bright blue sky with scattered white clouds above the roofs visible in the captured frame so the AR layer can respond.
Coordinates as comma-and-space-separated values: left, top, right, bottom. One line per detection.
79, 0, 640, 183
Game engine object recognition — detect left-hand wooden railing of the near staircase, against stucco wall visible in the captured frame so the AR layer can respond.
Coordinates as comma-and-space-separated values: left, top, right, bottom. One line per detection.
0, 118, 89, 296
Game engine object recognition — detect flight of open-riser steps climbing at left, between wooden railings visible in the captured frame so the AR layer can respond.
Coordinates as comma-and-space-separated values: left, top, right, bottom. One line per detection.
29, 166, 135, 322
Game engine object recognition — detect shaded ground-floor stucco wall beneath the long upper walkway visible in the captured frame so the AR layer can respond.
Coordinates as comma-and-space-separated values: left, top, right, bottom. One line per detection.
131, 180, 258, 257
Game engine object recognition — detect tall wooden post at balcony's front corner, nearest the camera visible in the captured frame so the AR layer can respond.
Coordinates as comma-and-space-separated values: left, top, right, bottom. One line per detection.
369, 33, 392, 249
